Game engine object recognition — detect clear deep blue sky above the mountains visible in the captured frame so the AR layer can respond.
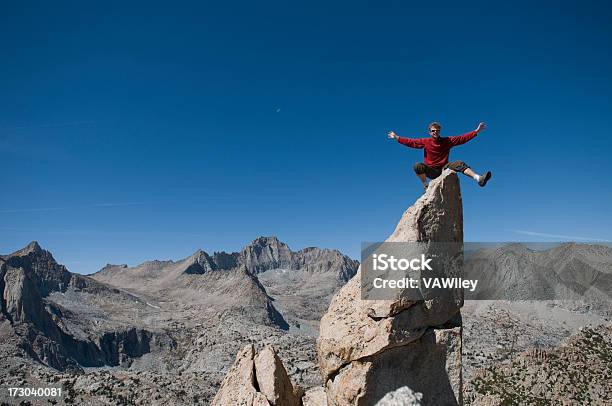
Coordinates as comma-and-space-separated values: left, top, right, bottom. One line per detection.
0, 1, 612, 273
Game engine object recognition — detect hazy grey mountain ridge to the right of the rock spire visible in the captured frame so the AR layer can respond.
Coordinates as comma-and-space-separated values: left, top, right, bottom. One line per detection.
464, 243, 612, 316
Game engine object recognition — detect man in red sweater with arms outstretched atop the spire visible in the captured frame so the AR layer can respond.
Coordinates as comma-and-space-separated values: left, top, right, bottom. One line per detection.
388, 122, 491, 192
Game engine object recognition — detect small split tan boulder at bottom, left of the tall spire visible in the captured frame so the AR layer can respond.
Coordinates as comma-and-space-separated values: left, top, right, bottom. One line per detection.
212, 345, 302, 406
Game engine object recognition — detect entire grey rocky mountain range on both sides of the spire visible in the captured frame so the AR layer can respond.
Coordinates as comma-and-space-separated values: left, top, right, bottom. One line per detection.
0, 230, 612, 404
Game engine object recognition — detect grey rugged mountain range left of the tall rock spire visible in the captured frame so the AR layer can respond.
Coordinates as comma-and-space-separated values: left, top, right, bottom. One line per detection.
0, 237, 359, 401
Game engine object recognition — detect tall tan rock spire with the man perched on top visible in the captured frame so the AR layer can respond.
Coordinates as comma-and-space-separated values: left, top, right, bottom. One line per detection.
317, 170, 463, 405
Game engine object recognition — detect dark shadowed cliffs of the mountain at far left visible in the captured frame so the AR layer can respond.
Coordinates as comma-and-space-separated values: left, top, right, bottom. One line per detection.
0, 242, 171, 371
